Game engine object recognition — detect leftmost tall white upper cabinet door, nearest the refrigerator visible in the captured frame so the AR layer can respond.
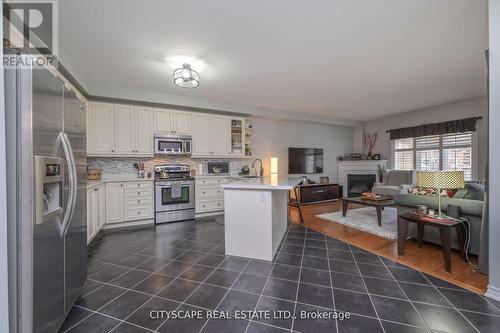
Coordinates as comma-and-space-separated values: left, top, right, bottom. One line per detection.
89, 103, 115, 154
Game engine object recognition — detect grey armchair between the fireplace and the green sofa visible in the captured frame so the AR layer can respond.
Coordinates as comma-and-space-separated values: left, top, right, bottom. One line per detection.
372, 169, 415, 195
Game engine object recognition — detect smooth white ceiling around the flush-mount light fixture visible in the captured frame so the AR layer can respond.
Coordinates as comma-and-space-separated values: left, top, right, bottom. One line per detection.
59, 0, 488, 120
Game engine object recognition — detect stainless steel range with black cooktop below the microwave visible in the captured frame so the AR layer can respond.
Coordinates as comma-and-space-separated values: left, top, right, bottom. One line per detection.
155, 164, 194, 224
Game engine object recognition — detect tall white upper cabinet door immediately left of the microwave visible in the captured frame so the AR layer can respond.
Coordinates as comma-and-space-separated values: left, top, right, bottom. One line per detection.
134, 106, 154, 154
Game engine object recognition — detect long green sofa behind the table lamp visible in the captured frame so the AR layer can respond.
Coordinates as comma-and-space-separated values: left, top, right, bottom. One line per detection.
394, 182, 484, 255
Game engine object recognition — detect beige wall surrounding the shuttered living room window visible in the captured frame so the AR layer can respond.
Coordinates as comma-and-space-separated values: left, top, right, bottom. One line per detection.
362, 97, 488, 179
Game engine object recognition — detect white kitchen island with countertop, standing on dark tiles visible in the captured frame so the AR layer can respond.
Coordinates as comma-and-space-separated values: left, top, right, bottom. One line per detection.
222, 176, 298, 261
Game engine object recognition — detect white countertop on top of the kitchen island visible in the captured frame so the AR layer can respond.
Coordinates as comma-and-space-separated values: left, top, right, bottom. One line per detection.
222, 176, 299, 191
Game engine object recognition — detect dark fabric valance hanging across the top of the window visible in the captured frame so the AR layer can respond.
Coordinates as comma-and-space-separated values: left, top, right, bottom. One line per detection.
388, 117, 481, 140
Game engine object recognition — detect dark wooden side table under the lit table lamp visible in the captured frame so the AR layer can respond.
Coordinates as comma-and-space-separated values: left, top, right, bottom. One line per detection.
398, 213, 467, 273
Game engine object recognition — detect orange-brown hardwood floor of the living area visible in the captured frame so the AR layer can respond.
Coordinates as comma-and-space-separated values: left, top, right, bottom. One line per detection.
289, 201, 488, 294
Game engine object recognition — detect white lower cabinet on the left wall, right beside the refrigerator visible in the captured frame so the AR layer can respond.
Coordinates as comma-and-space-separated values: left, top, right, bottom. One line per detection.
87, 184, 106, 244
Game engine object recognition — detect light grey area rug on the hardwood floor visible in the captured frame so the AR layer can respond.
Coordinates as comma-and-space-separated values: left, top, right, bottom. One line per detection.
316, 207, 398, 239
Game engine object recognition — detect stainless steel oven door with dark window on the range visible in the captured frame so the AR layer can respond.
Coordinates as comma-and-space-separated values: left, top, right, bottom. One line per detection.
155, 181, 194, 212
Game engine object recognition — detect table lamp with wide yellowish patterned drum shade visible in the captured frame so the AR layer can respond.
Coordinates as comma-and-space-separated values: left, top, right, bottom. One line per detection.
417, 171, 465, 218
